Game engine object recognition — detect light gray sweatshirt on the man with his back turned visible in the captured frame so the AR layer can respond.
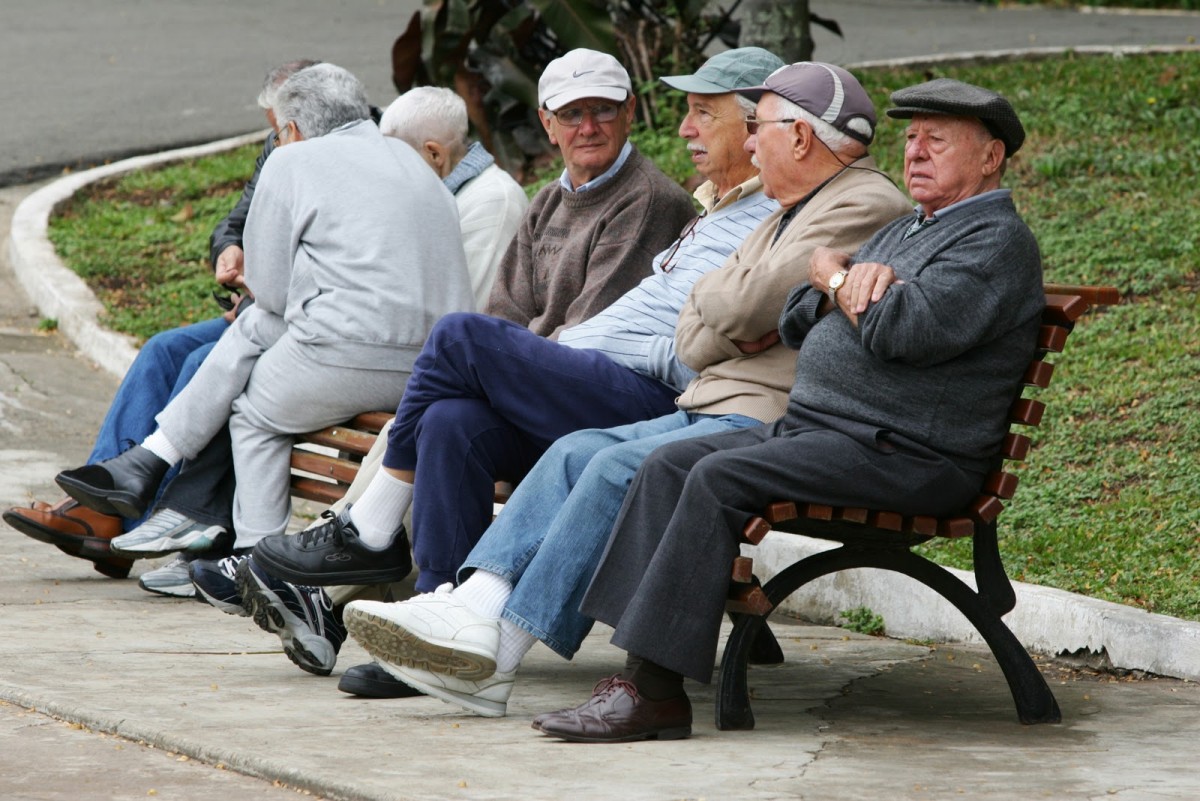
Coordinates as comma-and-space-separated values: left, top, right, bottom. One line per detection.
245, 120, 474, 371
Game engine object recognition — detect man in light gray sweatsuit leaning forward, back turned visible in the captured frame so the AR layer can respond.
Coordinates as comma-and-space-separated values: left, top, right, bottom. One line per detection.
58, 64, 474, 547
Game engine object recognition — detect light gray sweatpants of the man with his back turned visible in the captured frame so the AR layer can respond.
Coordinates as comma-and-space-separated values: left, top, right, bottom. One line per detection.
156, 309, 408, 548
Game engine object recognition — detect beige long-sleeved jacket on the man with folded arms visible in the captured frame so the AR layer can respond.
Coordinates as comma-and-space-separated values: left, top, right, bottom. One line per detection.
676, 157, 912, 422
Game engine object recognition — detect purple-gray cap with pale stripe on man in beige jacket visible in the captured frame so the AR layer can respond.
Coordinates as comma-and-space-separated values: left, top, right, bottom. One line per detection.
733, 61, 875, 145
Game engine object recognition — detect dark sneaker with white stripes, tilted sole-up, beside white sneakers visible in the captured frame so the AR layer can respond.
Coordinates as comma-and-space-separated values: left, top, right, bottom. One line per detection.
236, 556, 346, 676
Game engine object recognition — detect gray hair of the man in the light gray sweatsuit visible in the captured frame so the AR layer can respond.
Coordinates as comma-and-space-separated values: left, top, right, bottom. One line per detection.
275, 64, 371, 139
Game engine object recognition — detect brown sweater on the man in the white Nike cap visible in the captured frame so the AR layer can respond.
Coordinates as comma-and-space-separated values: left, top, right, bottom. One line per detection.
487, 149, 696, 338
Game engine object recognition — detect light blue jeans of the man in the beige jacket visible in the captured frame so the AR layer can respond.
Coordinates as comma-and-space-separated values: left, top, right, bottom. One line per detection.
460, 411, 761, 660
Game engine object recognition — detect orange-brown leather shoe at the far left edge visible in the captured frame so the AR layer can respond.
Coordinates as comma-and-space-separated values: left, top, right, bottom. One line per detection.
4, 498, 133, 578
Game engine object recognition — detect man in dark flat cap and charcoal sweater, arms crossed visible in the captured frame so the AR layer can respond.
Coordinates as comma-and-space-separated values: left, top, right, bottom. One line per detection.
520, 80, 1043, 742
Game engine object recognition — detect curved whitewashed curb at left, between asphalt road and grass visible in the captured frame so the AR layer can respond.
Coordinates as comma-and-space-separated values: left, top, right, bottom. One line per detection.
8, 132, 265, 378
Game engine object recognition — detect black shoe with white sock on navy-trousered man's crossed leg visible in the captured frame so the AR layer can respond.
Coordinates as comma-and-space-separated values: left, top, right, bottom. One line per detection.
254, 506, 413, 586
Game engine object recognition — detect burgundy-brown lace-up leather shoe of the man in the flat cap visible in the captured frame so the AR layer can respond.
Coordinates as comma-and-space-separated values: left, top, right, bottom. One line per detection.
538, 676, 691, 742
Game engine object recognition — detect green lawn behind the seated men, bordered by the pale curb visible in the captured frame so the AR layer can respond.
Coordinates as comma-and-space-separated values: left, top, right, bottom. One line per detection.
52, 53, 1200, 620
